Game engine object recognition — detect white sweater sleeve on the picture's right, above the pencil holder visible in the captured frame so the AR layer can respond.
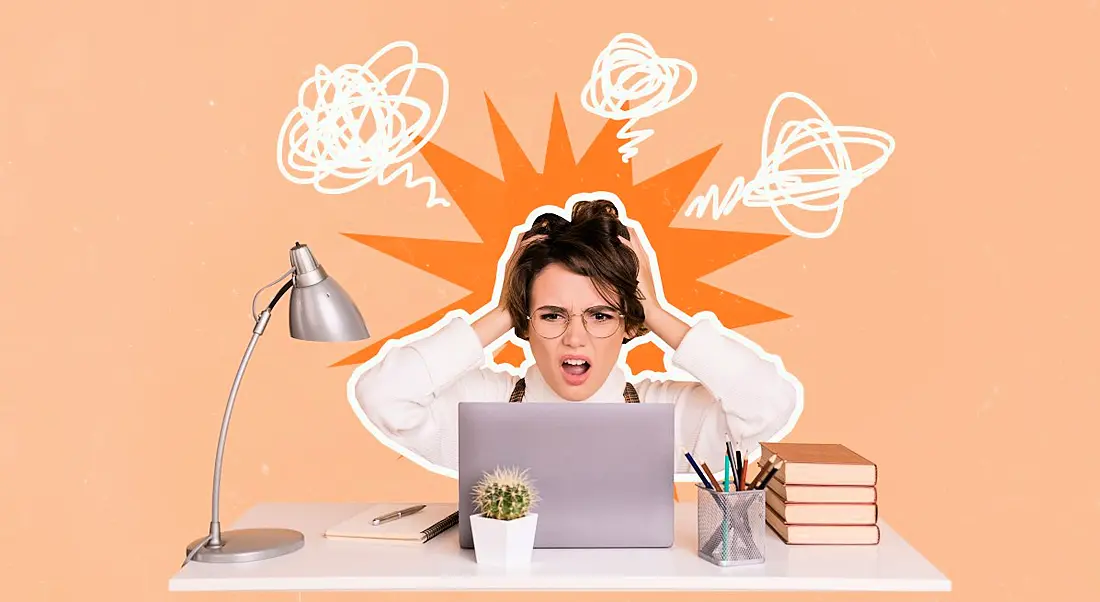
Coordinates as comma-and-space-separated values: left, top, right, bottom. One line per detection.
638, 319, 802, 474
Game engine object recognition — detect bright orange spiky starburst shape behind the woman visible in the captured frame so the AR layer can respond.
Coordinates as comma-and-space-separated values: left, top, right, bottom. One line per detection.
336, 96, 789, 373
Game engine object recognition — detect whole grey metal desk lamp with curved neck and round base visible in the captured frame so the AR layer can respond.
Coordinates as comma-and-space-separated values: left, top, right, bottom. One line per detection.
184, 242, 371, 565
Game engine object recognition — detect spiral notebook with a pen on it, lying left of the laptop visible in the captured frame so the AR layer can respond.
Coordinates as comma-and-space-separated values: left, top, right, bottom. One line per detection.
325, 503, 459, 543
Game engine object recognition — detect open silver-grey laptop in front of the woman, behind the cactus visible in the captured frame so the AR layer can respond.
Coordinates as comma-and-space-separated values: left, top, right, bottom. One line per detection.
459, 402, 675, 548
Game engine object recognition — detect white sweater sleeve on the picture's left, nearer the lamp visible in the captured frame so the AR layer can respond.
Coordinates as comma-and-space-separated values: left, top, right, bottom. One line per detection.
355, 318, 516, 469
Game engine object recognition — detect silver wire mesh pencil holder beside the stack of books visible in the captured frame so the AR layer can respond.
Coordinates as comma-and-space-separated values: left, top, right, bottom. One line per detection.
695, 483, 766, 567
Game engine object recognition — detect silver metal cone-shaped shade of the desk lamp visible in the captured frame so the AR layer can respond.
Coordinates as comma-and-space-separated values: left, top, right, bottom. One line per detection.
290, 243, 371, 342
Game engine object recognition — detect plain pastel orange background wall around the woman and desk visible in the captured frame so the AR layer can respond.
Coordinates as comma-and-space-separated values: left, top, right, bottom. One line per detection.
0, 0, 1100, 602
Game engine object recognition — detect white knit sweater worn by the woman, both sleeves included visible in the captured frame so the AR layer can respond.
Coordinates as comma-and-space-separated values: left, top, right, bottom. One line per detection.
353, 318, 802, 475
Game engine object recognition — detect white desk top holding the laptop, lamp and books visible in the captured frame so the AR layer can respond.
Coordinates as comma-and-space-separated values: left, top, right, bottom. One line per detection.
168, 502, 952, 592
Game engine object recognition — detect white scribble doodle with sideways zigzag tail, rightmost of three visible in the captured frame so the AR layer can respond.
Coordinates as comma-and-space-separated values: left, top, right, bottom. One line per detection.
685, 92, 894, 239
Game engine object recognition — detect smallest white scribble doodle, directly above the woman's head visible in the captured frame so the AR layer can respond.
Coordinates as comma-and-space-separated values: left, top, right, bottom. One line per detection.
581, 33, 699, 163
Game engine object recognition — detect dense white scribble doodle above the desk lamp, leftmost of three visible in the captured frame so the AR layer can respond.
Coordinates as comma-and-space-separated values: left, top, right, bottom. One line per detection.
278, 41, 450, 207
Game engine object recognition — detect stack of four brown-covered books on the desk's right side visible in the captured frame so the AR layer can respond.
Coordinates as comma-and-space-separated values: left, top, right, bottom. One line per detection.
757, 442, 880, 545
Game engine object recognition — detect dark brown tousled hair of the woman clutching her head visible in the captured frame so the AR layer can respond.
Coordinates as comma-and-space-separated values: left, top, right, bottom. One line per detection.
503, 200, 647, 342
